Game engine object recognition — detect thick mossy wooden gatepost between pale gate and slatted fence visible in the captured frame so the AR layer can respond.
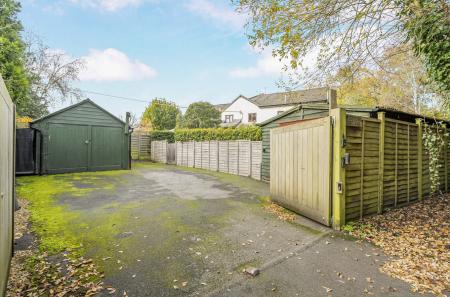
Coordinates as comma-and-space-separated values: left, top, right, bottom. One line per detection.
330, 108, 347, 230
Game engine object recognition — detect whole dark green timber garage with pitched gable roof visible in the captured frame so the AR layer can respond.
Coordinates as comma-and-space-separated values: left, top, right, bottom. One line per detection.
31, 99, 131, 174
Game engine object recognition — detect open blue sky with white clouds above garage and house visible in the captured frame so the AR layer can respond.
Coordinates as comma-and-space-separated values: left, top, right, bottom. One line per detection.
19, 0, 292, 117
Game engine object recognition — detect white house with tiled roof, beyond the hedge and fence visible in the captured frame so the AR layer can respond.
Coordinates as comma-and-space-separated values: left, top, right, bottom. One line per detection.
216, 88, 330, 126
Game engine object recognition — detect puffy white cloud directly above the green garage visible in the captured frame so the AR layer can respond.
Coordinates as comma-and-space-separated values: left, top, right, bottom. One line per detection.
80, 48, 157, 81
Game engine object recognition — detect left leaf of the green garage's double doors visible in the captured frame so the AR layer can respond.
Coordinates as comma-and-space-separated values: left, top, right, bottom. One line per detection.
47, 124, 90, 173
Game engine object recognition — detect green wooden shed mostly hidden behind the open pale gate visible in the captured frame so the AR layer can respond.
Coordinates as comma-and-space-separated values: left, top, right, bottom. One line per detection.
259, 103, 373, 182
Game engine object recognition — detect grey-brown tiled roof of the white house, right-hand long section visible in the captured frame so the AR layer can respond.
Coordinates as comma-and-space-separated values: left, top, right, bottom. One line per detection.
248, 87, 329, 107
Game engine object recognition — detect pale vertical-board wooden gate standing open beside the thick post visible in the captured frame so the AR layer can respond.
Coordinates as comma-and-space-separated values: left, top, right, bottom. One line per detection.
270, 117, 332, 226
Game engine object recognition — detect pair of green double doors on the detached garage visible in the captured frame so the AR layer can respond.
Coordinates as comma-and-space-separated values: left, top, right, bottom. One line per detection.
47, 124, 124, 173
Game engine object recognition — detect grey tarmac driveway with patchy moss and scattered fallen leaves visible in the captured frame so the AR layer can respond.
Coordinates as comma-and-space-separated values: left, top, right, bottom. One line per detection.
15, 163, 428, 296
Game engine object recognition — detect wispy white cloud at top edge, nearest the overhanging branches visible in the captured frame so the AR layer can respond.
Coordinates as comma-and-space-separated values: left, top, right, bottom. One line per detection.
186, 0, 246, 30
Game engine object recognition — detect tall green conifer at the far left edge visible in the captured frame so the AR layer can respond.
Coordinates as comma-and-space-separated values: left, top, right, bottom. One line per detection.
0, 0, 30, 114
